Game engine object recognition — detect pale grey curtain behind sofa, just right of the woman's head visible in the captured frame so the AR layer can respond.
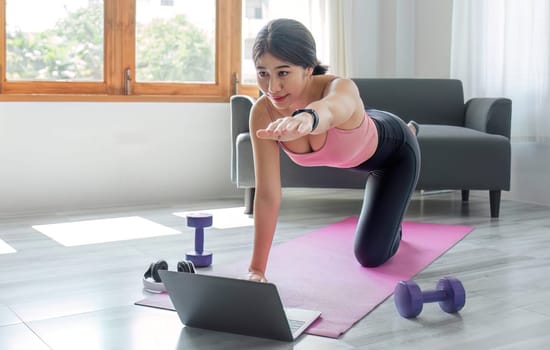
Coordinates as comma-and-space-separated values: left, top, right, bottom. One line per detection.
324, 0, 415, 78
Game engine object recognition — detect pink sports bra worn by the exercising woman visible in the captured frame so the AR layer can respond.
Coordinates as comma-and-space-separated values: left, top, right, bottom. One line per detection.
279, 112, 378, 168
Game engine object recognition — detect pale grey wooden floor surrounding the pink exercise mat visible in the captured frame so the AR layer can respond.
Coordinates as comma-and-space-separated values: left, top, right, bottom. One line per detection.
0, 189, 550, 350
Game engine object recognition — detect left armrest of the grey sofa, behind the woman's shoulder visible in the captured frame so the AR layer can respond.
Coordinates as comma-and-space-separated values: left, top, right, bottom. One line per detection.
229, 95, 255, 183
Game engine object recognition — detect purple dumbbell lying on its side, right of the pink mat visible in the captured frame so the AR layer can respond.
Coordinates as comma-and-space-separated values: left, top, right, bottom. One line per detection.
394, 277, 466, 318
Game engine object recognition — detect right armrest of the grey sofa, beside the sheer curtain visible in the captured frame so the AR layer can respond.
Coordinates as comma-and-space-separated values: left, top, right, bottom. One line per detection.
464, 98, 512, 139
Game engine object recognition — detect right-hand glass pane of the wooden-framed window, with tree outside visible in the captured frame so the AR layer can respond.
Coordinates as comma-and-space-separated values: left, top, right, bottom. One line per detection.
133, 0, 220, 94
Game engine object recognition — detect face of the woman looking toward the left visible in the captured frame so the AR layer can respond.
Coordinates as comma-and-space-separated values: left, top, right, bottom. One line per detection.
256, 53, 313, 110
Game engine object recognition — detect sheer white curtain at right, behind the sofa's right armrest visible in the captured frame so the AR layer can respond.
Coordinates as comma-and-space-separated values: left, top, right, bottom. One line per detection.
451, 0, 550, 142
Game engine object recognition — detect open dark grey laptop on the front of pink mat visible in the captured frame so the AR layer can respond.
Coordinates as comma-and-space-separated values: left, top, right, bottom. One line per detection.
159, 270, 321, 341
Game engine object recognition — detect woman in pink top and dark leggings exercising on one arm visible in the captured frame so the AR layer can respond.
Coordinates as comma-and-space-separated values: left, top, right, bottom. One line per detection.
248, 19, 420, 282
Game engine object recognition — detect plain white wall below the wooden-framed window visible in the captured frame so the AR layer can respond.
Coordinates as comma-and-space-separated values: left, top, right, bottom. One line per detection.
0, 102, 242, 216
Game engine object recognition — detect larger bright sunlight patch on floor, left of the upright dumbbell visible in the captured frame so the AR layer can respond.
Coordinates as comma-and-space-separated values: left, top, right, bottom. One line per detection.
33, 216, 181, 247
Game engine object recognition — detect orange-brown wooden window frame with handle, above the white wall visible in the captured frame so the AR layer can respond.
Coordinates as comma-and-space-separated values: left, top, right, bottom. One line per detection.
0, 0, 258, 102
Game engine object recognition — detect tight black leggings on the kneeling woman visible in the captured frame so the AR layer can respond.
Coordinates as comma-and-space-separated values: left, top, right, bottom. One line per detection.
354, 109, 420, 267
